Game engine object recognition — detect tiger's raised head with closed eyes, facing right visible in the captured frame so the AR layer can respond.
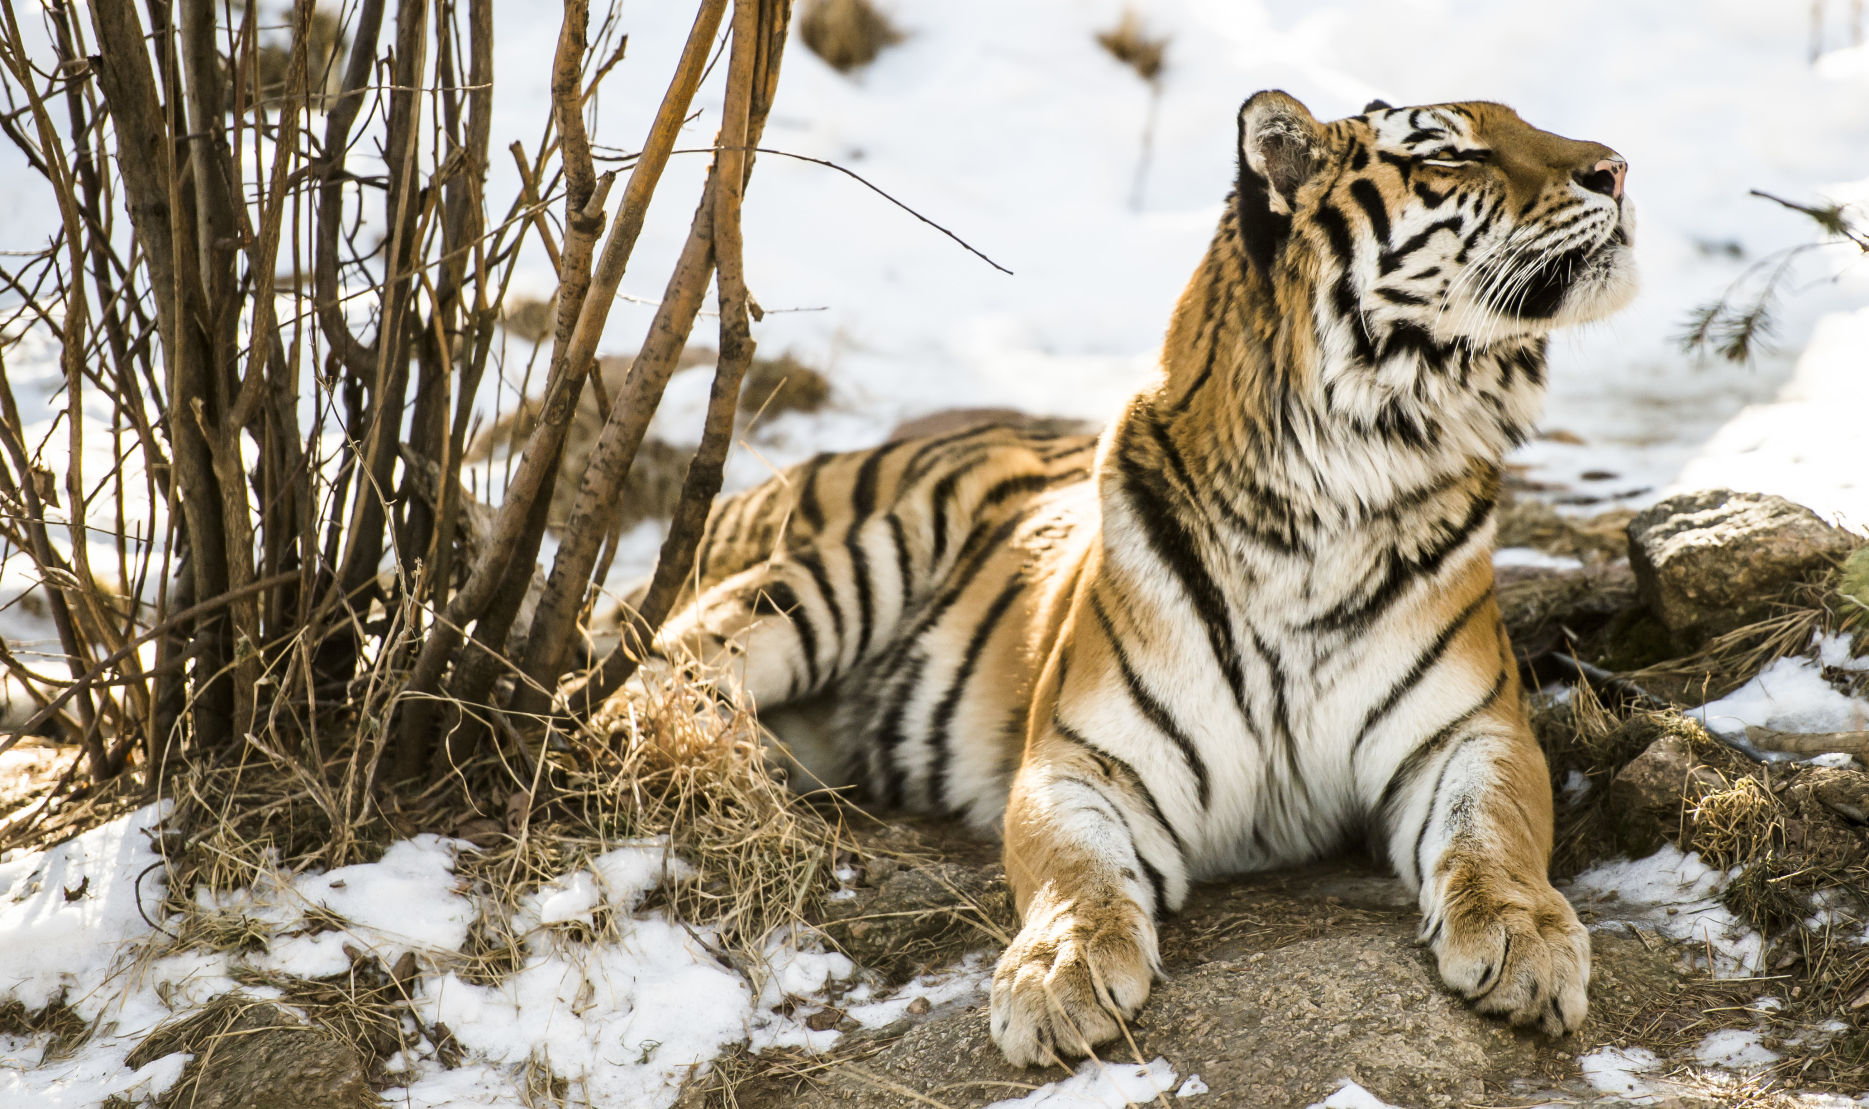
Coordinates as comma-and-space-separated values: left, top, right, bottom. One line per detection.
1237, 90, 1635, 349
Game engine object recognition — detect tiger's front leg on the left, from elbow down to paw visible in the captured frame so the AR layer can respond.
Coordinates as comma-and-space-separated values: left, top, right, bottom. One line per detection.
991, 718, 1187, 1066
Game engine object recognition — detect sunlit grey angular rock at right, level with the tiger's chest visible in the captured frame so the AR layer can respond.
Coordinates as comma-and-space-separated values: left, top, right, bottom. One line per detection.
1628, 490, 1862, 647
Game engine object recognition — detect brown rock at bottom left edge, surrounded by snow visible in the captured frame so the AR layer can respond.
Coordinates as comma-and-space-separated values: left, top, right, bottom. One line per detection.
129, 993, 378, 1109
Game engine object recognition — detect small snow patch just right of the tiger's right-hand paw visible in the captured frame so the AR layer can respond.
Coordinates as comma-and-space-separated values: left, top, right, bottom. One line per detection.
1570, 843, 1764, 978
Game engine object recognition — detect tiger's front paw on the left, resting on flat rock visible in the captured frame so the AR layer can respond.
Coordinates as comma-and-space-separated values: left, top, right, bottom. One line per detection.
992, 892, 1155, 1066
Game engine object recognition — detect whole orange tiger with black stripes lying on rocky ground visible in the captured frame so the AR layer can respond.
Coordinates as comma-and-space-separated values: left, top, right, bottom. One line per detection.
613, 90, 1635, 1066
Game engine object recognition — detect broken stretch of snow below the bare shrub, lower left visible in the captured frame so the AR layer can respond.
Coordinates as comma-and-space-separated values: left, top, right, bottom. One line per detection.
0, 806, 964, 1109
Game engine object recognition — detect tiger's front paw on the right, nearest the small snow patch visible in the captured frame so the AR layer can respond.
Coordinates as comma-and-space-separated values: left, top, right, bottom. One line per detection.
1428, 870, 1591, 1036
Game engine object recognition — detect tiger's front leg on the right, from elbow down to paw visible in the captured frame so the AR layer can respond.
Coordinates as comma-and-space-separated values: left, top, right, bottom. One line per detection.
1385, 698, 1591, 1036
